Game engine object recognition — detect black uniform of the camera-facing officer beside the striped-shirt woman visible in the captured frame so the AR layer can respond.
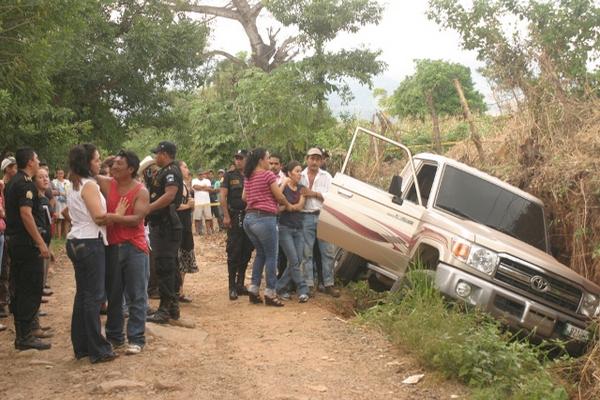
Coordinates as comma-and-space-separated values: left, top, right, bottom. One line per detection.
221, 170, 254, 294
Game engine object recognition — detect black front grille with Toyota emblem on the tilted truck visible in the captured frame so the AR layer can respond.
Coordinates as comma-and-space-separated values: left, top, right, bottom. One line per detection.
494, 258, 582, 312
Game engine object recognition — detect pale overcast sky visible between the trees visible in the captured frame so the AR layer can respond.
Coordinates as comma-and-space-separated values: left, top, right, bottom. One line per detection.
203, 0, 492, 119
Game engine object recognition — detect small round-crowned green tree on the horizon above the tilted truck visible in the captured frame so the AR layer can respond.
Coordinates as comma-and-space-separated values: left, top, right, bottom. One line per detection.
390, 59, 486, 152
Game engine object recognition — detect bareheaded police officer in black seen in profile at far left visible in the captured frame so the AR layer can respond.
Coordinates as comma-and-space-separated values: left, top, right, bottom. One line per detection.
5, 147, 50, 350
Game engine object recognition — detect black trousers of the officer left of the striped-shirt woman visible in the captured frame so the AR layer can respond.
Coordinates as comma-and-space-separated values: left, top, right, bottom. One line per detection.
226, 210, 254, 290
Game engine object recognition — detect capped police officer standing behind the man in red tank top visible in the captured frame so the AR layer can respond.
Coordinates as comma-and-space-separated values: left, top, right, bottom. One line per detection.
147, 141, 183, 324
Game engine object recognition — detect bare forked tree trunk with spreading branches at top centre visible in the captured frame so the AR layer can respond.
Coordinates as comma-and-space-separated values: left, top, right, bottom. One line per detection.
166, 0, 299, 72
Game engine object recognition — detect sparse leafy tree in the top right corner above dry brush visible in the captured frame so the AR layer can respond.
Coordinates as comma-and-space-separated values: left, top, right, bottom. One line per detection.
428, 0, 600, 104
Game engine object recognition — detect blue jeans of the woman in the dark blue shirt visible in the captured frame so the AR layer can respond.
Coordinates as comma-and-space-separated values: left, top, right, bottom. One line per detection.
277, 225, 308, 294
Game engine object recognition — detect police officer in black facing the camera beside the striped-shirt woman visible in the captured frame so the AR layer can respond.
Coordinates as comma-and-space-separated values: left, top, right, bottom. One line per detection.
221, 150, 254, 300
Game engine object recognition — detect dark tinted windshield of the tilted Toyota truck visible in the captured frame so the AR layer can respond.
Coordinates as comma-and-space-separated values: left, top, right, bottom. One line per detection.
435, 165, 547, 252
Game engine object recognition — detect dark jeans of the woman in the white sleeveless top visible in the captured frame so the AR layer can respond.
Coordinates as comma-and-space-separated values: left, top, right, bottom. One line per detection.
67, 239, 112, 361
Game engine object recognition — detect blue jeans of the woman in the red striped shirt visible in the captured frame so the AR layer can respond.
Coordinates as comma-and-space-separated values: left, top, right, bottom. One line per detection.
244, 212, 279, 297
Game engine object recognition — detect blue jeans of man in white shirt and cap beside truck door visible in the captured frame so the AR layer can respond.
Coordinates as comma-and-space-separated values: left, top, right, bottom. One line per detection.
302, 214, 335, 287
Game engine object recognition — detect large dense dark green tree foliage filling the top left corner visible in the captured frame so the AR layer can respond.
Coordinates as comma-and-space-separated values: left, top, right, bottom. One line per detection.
0, 0, 207, 165
